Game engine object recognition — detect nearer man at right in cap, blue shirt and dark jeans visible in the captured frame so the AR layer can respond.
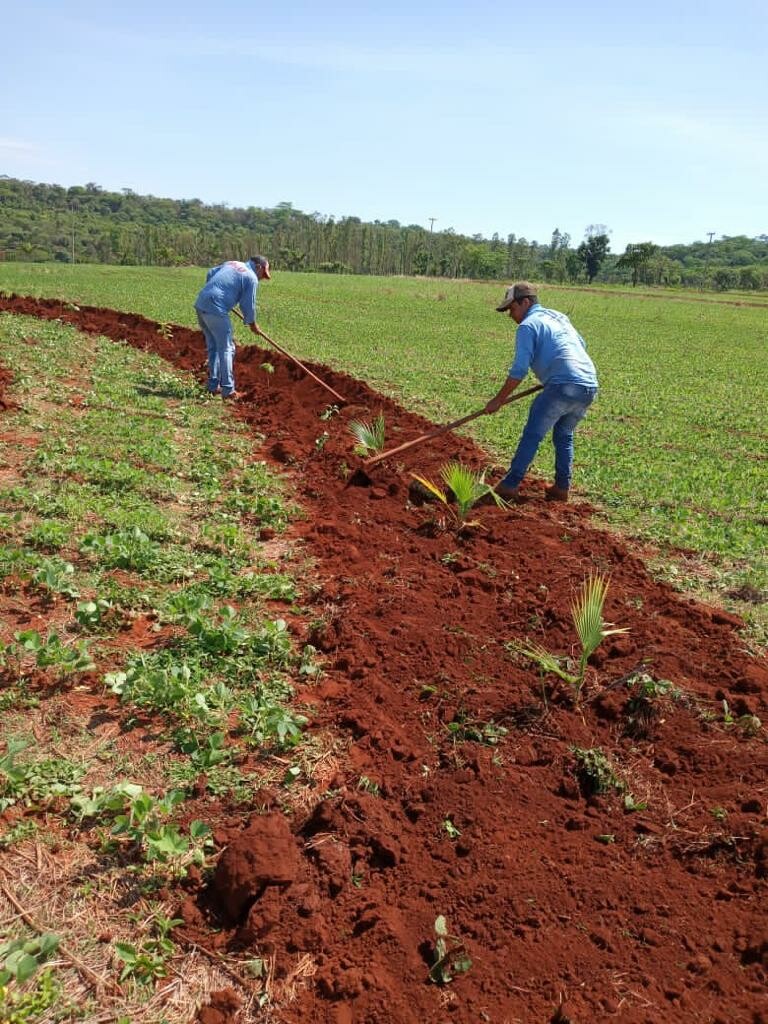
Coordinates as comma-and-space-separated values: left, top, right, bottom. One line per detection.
484, 281, 597, 502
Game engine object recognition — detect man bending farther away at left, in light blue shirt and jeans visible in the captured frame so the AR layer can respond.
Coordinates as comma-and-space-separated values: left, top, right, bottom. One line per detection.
195, 256, 271, 399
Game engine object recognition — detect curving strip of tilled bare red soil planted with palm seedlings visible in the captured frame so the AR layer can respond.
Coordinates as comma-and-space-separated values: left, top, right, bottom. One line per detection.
0, 298, 768, 1024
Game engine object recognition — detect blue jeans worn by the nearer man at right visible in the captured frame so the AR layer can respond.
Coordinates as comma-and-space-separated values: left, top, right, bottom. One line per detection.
501, 384, 597, 490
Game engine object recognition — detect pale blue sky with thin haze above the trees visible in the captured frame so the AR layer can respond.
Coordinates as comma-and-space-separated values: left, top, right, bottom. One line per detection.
0, 0, 768, 252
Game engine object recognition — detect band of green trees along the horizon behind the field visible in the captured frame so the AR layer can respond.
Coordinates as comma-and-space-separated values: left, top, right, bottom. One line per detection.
0, 175, 768, 290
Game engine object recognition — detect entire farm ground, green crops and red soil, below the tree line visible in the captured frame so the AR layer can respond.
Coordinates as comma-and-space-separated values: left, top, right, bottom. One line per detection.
0, 264, 768, 1024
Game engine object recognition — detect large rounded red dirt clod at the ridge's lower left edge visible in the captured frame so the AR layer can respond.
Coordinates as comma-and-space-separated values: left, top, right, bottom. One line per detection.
212, 814, 299, 921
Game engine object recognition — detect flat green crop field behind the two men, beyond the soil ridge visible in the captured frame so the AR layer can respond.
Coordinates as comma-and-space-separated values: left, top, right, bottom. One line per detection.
0, 264, 768, 606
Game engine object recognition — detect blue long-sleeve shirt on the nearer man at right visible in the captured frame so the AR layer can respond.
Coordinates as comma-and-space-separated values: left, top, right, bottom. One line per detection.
509, 302, 597, 387
